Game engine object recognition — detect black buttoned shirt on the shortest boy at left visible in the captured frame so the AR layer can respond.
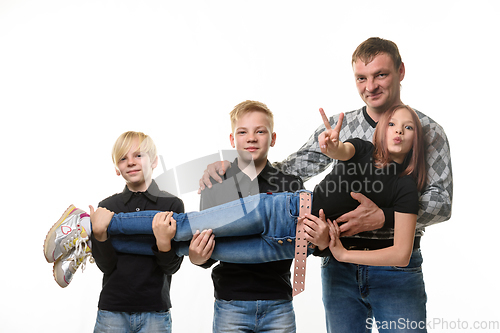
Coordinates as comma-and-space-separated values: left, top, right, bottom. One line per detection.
92, 180, 184, 312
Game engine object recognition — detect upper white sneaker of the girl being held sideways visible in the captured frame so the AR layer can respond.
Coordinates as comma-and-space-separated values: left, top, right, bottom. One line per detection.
43, 205, 90, 263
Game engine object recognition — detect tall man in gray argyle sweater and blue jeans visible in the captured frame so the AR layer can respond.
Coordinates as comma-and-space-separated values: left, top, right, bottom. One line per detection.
200, 38, 453, 333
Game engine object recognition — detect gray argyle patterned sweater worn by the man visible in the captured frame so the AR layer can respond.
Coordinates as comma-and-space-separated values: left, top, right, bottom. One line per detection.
274, 107, 453, 239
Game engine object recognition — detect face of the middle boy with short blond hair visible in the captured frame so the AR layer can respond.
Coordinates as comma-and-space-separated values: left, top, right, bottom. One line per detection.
229, 111, 276, 164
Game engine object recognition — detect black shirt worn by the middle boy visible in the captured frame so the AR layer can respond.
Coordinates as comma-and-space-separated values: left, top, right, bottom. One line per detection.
200, 161, 303, 301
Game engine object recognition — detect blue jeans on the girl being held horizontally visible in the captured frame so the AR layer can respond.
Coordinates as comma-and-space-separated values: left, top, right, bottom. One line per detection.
108, 194, 282, 256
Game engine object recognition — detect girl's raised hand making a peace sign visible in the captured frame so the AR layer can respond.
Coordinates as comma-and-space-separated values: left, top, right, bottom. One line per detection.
318, 108, 355, 161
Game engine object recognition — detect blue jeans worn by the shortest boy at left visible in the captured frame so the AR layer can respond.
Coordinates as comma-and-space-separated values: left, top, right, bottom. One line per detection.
94, 310, 172, 333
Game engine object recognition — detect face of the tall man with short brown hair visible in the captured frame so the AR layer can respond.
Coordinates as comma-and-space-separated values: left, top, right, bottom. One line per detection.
353, 53, 405, 114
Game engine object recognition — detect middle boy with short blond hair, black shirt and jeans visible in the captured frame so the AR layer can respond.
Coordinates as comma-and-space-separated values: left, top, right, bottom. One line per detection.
190, 101, 303, 333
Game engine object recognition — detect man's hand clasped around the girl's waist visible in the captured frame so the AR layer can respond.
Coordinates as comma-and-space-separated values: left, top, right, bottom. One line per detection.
336, 192, 385, 237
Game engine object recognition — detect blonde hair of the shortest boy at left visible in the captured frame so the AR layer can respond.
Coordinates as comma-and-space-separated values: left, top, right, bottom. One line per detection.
111, 131, 156, 166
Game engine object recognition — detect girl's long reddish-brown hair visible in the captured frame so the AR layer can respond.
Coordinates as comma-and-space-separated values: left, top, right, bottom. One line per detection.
373, 105, 427, 191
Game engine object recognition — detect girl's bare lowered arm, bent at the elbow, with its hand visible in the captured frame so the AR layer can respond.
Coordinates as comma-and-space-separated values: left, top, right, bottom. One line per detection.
328, 212, 417, 267
